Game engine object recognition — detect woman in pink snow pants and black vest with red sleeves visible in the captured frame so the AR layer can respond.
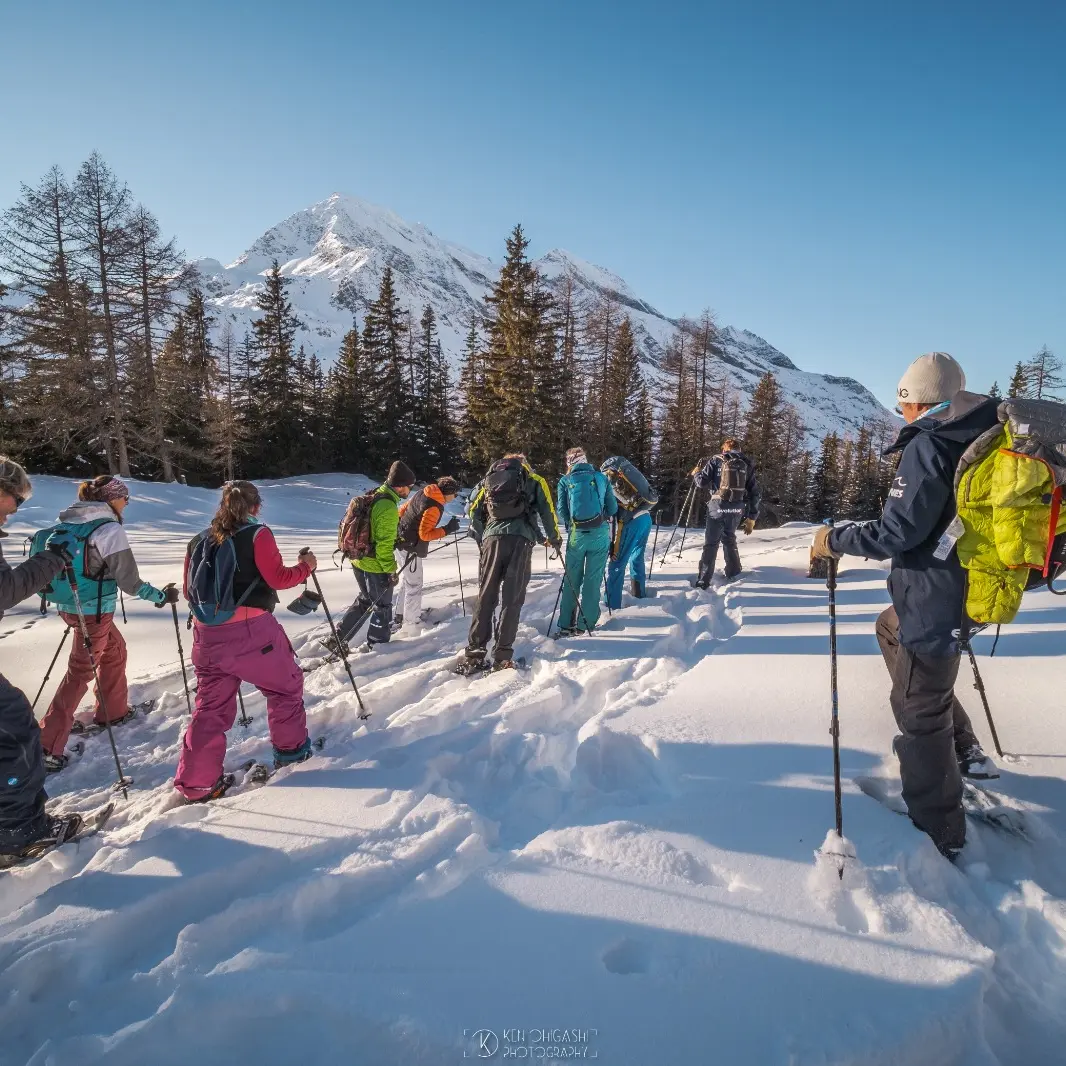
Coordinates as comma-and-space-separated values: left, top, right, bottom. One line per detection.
174, 481, 318, 803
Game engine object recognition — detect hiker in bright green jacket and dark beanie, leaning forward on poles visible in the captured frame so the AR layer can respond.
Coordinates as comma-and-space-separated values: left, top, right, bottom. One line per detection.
337, 462, 415, 651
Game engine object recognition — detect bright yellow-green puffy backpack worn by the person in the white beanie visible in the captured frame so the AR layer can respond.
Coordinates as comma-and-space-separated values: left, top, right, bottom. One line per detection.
944, 399, 1066, 625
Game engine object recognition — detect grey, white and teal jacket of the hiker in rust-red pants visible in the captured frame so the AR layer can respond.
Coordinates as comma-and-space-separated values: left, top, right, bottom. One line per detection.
34, 500, 166, 614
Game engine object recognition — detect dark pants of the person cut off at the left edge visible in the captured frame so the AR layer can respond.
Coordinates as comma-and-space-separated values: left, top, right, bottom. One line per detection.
0, 675, 51, 855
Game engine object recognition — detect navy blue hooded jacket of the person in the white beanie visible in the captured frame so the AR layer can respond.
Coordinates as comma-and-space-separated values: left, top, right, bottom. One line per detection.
829, 392, 999, 658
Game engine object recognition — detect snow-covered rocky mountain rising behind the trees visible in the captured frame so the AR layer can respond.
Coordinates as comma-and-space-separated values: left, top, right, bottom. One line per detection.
197, 194, 886, 438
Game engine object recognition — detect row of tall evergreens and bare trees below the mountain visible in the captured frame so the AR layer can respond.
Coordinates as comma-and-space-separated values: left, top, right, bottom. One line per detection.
0, 154, 1048, 523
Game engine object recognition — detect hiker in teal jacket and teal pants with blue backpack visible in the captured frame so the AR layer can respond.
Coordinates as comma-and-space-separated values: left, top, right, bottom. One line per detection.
555, 448, 618, 636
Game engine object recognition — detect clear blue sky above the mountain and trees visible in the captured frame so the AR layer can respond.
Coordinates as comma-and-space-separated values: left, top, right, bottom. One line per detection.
0, 0, 1066, 401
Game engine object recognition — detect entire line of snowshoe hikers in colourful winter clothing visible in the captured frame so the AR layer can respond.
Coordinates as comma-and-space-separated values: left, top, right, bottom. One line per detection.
0, 353, 1066, 861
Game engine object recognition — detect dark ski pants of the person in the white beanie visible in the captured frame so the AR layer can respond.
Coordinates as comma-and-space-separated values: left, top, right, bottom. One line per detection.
876, 607, 978, 847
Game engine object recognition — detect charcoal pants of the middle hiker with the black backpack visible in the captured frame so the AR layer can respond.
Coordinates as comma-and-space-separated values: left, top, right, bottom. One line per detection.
466, 533, 533, 662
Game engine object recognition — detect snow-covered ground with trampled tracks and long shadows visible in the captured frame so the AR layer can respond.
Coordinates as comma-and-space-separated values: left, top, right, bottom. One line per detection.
0, 477, 1066, 1066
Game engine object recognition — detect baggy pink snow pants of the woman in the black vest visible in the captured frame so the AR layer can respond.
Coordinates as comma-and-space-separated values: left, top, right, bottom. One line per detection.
174, 614, 307, 800
